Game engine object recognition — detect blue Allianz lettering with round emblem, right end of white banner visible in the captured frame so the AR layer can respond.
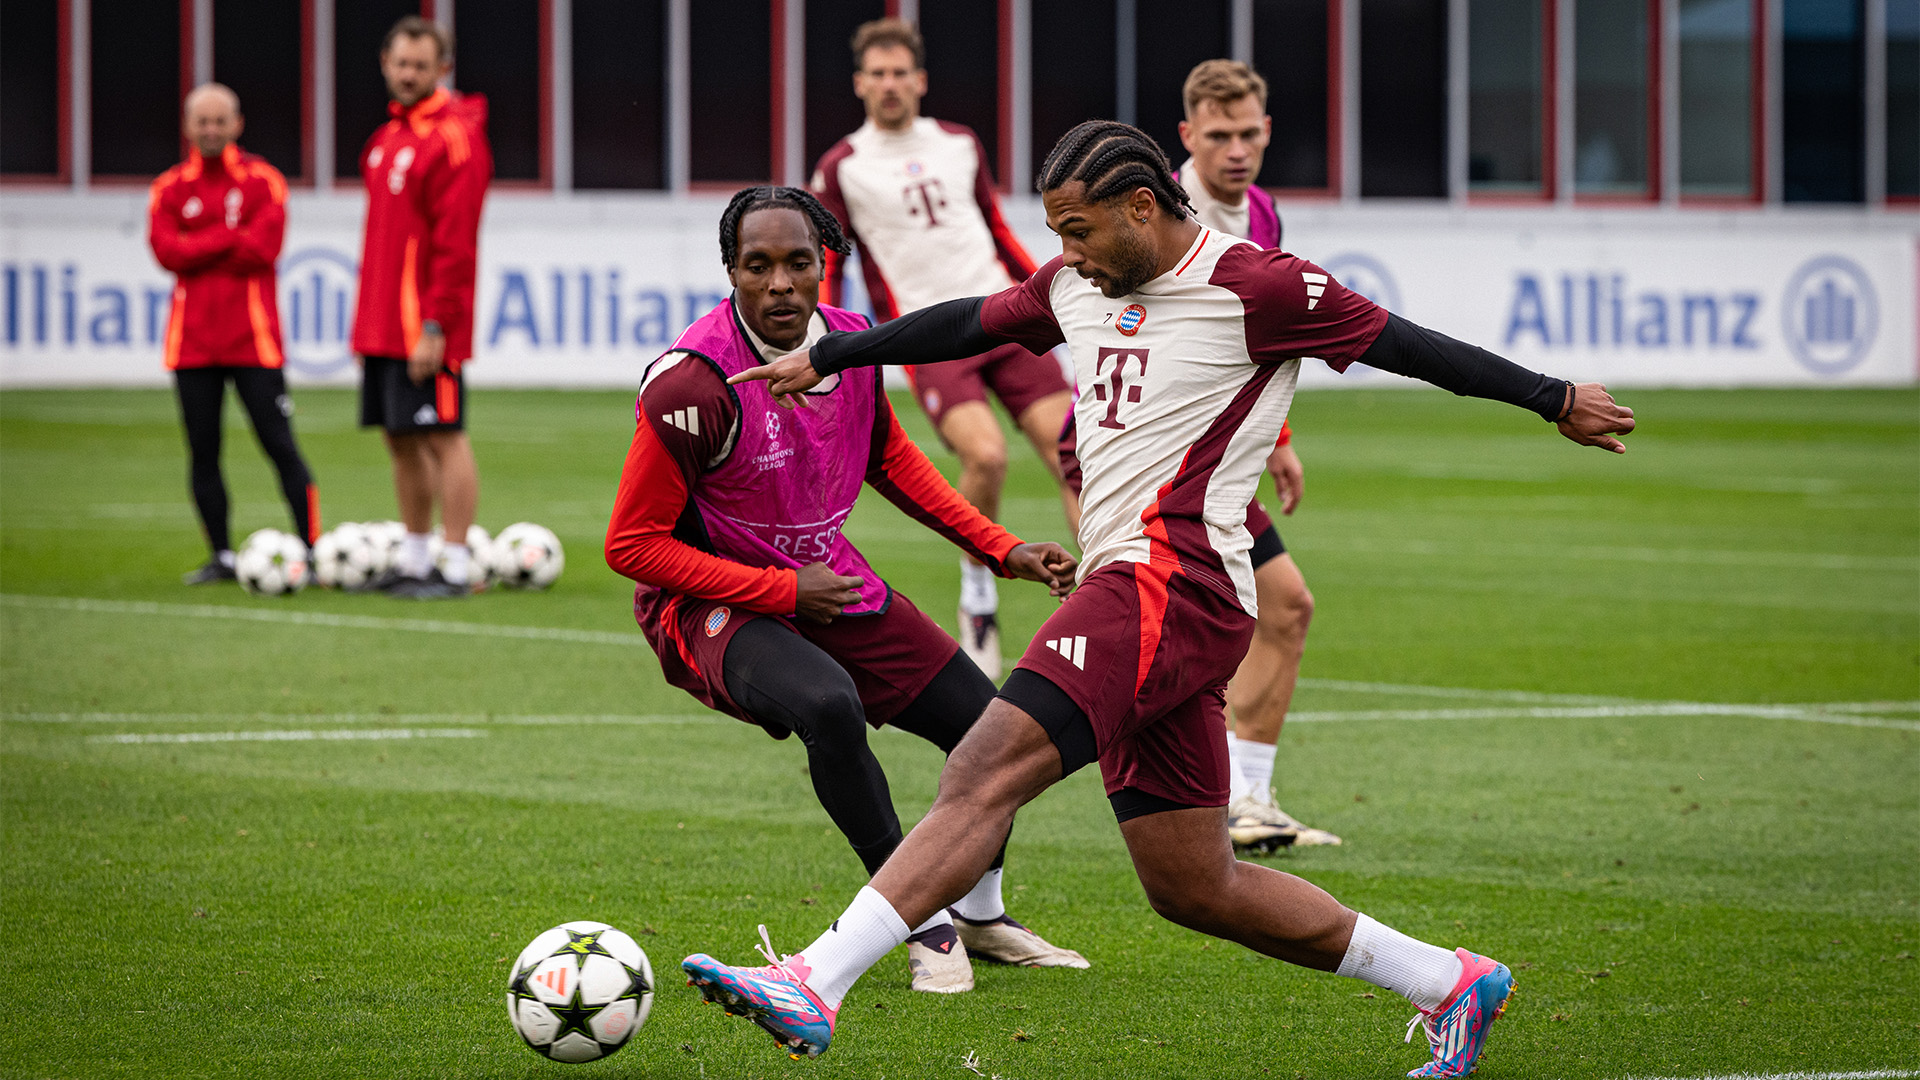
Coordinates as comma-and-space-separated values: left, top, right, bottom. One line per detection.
1501, 256, 1878, 375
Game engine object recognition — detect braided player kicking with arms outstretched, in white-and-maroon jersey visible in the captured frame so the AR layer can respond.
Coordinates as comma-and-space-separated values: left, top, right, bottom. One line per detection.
682, 121, 1634, 1076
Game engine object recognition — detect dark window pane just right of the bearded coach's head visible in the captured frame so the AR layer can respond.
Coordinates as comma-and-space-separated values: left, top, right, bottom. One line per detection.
453, 0, 541, 181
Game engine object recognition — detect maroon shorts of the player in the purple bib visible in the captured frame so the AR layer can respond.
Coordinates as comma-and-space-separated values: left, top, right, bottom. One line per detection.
636, 592, 960, 736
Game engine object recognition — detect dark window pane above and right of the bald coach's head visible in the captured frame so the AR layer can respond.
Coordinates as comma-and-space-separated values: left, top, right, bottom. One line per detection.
213, 0, 307, 177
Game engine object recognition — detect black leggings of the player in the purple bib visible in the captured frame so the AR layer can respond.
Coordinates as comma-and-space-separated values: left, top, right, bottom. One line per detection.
724, 617, 1006, 874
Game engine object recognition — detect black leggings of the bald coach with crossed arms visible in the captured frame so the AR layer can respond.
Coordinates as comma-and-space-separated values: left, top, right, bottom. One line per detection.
173, 367, 319, 552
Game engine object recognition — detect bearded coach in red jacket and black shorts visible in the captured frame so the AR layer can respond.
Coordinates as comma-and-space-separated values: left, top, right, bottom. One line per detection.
353, 15, 493, 600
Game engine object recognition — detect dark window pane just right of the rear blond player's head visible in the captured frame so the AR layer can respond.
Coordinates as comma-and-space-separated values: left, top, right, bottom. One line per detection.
1254, 0, 1338, 188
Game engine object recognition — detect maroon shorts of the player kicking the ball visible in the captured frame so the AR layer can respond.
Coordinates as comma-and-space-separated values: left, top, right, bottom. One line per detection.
1016, 563, 1254, 807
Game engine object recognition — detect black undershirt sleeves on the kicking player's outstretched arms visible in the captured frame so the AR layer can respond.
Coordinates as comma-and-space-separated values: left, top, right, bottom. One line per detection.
812, 296, 1567, 421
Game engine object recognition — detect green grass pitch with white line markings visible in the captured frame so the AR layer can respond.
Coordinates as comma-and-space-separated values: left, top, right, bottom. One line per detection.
0, 382, 1920, 1080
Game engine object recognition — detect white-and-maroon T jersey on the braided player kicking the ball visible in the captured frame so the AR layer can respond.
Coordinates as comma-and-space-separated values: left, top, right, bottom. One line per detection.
979, 229, 1386, 613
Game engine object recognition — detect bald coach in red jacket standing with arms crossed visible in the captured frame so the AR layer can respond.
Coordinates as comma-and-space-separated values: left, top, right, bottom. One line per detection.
148, 83, 321, 584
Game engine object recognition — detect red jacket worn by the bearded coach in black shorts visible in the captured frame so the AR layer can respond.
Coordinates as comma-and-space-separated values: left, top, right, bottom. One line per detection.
353, 88, 493, 371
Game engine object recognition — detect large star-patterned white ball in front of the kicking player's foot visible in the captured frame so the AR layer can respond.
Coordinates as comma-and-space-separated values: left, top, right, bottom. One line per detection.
507, 922, 653, 1063
